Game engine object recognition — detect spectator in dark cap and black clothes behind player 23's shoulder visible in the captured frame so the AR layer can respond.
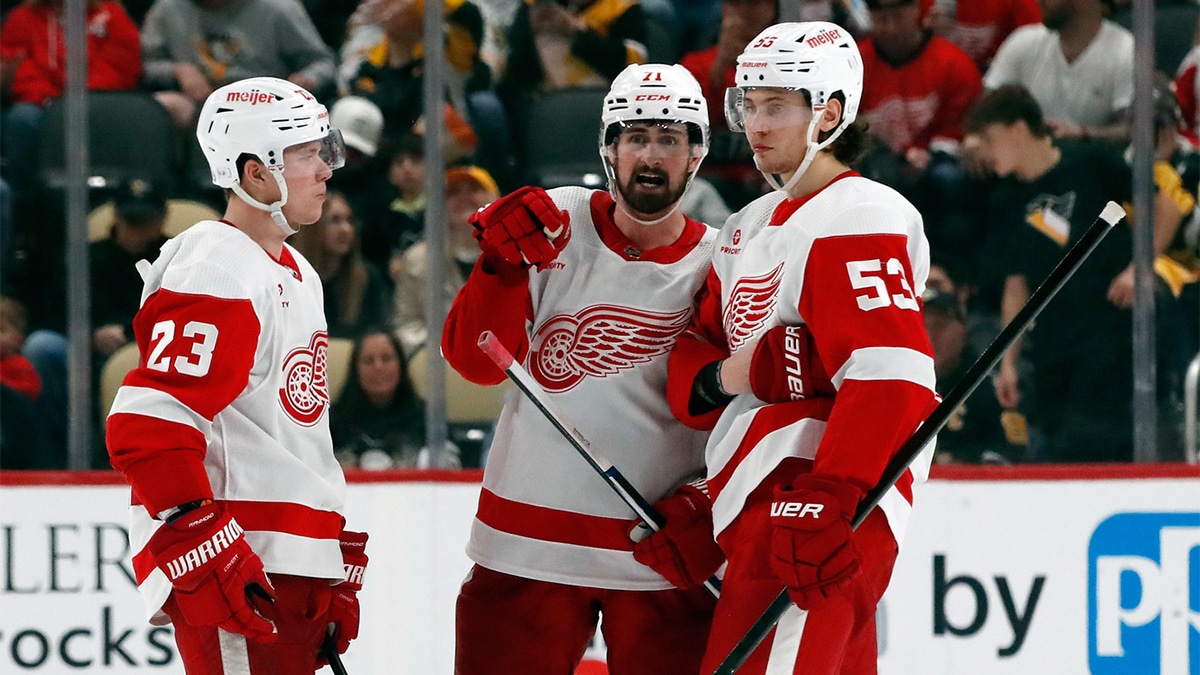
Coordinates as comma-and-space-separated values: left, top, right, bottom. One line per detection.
89, 178, 167, 360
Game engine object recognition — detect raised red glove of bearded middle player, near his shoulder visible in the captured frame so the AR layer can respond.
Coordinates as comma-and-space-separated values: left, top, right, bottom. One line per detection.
469, 186, 571, 270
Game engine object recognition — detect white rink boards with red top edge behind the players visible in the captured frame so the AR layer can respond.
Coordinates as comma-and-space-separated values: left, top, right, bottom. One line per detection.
0, 465, 1200, 675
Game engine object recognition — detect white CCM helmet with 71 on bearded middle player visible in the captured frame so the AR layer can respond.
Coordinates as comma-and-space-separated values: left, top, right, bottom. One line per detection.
599, 64, 709, 222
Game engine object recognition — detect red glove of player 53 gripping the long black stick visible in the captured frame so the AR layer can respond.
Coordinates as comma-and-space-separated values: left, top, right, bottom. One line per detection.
770, 473, 863, 609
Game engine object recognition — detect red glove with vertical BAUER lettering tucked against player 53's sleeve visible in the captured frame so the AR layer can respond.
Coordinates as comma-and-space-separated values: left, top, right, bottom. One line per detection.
750, 325, 836, 404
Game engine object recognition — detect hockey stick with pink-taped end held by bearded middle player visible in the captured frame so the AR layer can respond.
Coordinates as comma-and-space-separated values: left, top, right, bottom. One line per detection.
479, 330, 721, 598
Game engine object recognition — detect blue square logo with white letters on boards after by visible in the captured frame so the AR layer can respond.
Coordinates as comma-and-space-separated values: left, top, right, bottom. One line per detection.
1087, 513, 1200, 675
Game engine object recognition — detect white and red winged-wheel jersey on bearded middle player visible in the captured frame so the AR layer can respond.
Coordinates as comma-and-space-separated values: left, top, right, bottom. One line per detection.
443, 187, 715, 591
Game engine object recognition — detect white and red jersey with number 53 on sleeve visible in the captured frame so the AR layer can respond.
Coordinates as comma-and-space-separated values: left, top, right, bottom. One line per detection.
671, 172, 936, 540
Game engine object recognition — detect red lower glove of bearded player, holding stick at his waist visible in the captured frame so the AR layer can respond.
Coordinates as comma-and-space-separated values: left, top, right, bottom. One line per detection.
630, 480, 725, 590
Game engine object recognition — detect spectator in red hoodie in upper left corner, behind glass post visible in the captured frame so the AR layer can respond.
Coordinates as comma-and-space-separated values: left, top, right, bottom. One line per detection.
0, 0, 142, 191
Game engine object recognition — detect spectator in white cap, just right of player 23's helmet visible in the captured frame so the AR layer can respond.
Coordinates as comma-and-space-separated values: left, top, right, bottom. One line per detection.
325, 91, 386, 214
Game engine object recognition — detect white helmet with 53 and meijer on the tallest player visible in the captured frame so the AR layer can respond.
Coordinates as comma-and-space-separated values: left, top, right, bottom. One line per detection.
725, 22, 863, 187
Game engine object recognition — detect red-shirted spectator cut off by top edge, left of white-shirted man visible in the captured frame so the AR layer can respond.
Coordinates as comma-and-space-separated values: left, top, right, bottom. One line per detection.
920, 0, 1042, 73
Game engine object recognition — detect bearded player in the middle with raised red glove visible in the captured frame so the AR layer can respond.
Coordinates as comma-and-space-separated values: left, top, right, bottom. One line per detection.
442, 64, 722, 675
